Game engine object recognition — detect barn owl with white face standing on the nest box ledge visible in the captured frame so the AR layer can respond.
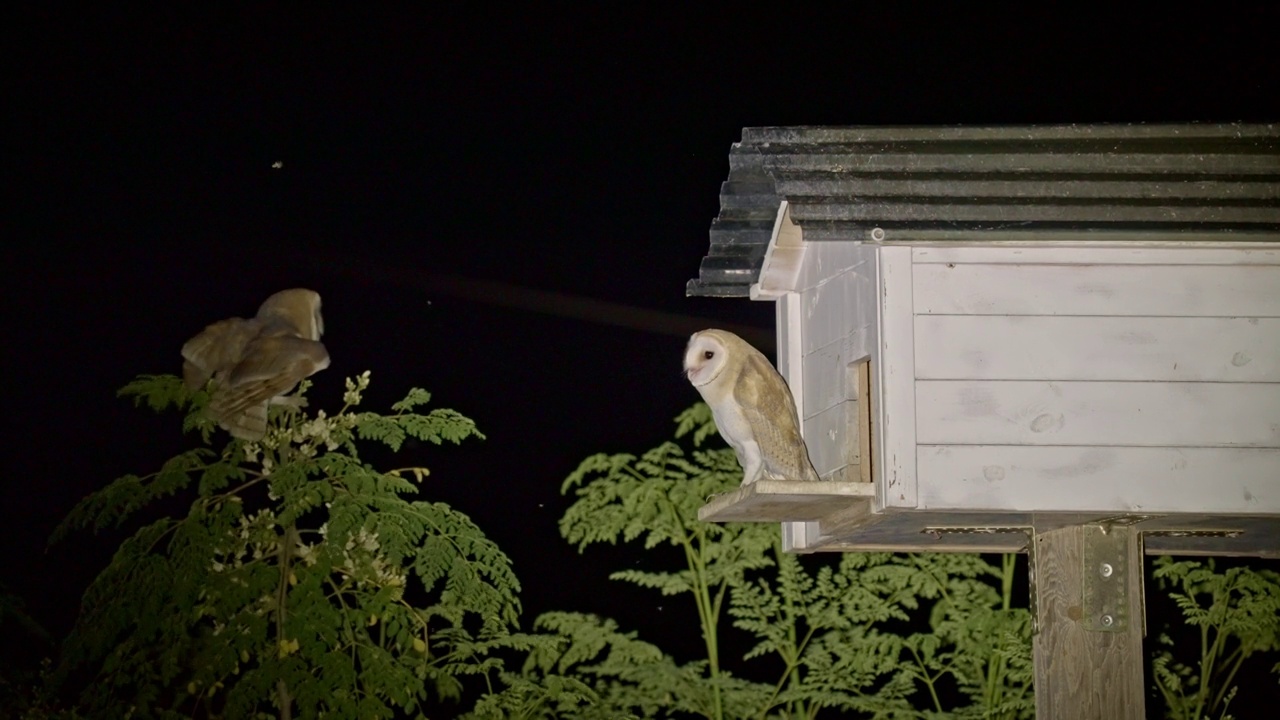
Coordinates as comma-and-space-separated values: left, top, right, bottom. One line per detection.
685, 329, 818, 486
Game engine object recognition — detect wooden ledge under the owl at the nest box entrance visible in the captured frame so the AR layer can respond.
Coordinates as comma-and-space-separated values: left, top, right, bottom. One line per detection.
698, 480, 876, 523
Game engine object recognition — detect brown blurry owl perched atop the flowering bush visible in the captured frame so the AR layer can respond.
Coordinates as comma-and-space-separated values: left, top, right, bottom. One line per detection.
182, 288, 329, 441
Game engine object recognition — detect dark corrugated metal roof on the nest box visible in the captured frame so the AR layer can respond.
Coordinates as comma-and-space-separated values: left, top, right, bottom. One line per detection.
687, 124, 1280, 296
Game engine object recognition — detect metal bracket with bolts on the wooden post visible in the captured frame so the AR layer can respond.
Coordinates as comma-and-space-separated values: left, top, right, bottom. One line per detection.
1080, 525, 1142, 633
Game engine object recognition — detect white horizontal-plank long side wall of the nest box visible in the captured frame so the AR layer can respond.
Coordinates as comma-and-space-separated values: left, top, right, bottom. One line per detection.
910, 247, 1280, 514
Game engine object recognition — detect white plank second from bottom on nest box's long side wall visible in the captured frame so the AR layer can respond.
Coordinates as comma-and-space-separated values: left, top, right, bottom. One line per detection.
915, 380, 1280, 447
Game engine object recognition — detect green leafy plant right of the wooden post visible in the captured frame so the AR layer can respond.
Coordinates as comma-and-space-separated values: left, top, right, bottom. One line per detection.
1152, 557, 1280, 720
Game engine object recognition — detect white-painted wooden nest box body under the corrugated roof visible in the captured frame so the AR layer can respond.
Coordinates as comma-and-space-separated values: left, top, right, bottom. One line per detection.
732, 236, 1280, 555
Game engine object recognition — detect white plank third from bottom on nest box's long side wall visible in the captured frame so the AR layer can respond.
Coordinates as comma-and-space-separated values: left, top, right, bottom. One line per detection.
915, 315, 1280, 383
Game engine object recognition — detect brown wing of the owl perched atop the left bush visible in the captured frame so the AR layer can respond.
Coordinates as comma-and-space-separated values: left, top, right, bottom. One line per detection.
209, 336, 329, 439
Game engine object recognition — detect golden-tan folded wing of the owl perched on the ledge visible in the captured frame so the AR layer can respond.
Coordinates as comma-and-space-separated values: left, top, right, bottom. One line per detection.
733, 354, 818, 480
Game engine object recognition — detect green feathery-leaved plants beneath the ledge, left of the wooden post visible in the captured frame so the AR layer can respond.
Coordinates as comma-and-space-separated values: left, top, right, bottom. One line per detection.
483, 405, 1033, 720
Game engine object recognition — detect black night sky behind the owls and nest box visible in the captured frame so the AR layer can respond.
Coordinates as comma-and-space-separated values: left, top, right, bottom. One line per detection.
0, 3, 1280, 676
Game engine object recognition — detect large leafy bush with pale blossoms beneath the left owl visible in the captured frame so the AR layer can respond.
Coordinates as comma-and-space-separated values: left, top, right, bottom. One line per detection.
48, 372, 538, 717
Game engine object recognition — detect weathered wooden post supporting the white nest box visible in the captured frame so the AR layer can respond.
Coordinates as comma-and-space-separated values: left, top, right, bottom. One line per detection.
1032, 527, 1146, 720
